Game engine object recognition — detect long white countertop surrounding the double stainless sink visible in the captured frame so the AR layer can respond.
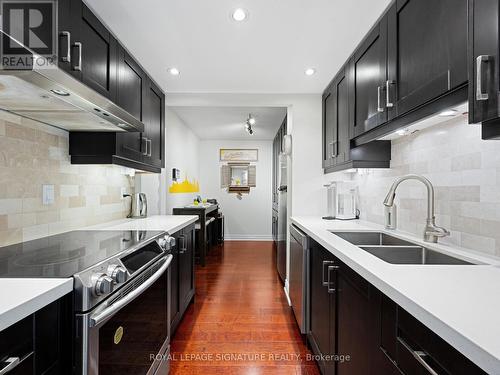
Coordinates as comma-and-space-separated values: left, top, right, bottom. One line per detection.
291, 217, 500, 374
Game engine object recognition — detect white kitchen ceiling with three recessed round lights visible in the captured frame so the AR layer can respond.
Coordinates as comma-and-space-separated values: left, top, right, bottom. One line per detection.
86, 0, 390, 93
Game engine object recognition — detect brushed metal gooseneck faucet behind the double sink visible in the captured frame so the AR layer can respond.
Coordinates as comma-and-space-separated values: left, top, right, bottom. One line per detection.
384, 174, 450, 243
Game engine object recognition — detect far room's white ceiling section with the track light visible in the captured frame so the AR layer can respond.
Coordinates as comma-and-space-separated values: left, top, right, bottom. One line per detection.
169, 107, 286, 141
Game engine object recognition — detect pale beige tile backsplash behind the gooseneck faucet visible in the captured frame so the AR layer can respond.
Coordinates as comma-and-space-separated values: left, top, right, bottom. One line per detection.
327, 116, 500, 256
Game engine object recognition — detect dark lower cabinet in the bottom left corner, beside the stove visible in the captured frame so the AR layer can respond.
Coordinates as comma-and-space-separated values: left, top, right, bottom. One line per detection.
0, 294, 74, 375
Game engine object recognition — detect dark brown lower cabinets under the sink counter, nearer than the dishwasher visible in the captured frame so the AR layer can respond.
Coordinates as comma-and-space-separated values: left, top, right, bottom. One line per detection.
308, 241, 486, 375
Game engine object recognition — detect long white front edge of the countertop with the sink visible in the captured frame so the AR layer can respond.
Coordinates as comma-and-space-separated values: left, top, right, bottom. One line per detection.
290, 217, 500, 374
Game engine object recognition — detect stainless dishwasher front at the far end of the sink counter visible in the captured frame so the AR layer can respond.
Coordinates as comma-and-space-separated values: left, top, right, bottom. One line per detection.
289, 225, 309, 334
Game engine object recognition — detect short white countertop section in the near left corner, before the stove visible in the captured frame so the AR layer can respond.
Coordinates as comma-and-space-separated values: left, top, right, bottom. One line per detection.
0, 278, 73, 331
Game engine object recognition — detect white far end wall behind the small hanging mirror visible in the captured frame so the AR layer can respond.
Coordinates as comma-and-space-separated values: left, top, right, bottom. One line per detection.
199, 140, 272, 240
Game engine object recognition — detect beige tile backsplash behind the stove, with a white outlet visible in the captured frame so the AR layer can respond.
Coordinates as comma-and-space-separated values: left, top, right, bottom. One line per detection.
0, 111, 134, 246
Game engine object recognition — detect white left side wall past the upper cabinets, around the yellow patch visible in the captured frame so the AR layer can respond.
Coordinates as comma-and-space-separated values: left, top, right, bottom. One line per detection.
136, 107, 200, 215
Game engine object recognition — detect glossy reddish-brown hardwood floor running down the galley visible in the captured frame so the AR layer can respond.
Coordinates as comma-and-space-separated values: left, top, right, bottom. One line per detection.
171, 241, 319, 375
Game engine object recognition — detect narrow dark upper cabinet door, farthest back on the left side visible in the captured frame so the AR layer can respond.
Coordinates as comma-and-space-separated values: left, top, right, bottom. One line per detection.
144, 79, 165, 168
